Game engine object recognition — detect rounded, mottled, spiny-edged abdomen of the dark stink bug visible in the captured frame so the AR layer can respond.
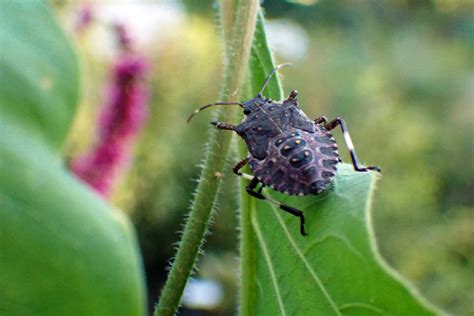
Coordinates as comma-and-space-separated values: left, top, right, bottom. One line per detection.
247, 124, 340, 195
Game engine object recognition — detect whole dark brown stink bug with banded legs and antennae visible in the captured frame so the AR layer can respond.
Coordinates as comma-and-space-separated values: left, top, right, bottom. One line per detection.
188, 64, 380, 236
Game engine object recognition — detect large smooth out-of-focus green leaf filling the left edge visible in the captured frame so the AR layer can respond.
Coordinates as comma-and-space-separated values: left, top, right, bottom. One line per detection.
0, 1, 145, 315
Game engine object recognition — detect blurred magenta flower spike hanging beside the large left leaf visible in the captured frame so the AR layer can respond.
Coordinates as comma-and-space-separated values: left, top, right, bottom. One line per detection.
71, 24, 149, 197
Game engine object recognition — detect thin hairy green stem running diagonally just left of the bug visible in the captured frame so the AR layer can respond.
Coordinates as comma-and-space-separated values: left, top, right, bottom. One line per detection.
154, 0, 259, 316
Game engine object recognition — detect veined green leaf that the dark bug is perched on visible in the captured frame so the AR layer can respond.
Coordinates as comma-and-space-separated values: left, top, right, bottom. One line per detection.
240, 11, 436, 315
